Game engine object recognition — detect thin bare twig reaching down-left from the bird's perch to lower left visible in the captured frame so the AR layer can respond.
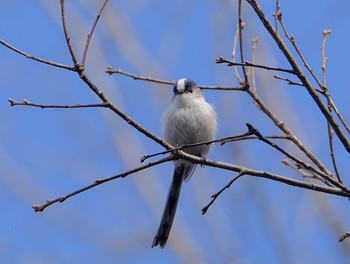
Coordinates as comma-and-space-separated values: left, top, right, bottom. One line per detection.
32, 156, 174, 212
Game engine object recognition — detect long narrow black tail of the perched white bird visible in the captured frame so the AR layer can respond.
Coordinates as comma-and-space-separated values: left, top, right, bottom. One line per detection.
152, 164, 186, 248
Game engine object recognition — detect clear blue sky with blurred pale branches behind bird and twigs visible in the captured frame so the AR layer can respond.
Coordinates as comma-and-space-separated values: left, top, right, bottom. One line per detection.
0, 0, 350, 263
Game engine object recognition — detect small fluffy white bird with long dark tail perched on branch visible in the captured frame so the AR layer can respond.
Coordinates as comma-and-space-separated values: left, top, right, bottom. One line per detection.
152, 78, 217, 248
